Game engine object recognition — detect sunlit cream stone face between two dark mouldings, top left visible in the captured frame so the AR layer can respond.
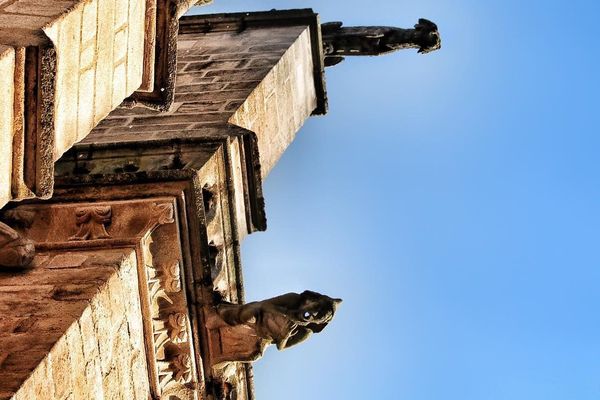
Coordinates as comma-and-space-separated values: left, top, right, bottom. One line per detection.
44, 0, 146, 160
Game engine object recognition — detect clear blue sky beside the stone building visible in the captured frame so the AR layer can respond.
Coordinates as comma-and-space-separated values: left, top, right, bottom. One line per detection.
193, 0, 600, 400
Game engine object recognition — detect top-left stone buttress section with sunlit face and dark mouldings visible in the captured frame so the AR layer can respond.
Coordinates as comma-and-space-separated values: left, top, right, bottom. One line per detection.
0, 0, 211, 207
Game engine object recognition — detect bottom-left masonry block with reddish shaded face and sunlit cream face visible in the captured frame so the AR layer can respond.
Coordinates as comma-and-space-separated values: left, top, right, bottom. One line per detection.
0, 250, 149, 400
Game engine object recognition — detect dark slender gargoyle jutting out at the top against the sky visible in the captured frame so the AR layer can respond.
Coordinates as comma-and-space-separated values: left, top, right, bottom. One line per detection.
321, 18, 441, 66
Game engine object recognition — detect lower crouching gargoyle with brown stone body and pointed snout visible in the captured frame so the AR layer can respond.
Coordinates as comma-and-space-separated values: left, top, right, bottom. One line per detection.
207, 290, 342, 364
